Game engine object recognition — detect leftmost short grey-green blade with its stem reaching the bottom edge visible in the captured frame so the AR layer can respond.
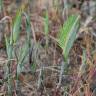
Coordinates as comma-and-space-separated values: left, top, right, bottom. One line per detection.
5, 35, 13, 96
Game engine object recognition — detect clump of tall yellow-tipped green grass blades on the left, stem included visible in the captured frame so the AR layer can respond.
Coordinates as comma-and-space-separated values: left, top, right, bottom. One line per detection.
5, 5, 31, 96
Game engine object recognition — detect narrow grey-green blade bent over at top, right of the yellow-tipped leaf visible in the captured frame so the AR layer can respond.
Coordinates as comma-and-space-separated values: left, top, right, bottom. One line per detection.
17, 13, 31, 78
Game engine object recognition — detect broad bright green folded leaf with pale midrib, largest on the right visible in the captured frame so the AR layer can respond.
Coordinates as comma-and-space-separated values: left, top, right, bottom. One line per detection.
57, 15, 80, 60
